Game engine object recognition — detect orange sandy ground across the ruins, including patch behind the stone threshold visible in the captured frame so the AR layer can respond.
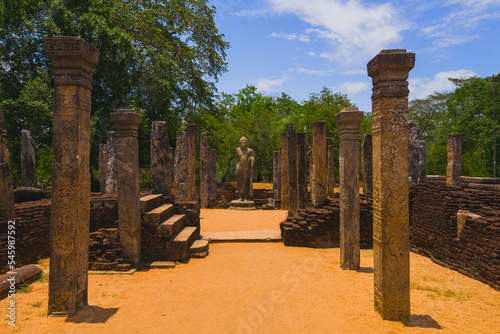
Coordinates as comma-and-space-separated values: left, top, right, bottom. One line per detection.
0, 210, 500, 334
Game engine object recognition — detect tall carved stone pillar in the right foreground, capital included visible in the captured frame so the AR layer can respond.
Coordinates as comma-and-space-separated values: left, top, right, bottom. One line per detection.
367, 49, 415, 320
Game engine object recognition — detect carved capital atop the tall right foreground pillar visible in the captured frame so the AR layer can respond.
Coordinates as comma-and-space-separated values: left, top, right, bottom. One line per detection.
367, 49, 415, 101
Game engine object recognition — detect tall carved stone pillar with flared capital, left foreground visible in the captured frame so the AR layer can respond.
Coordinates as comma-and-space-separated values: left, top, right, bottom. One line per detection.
44, 37, 99, 317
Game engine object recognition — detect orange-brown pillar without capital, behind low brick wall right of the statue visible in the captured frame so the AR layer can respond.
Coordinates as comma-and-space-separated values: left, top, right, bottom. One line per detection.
311, 121, 327, 207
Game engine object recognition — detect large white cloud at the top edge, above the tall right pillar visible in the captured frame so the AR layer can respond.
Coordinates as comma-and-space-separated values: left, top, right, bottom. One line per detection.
268, 0, 408, 62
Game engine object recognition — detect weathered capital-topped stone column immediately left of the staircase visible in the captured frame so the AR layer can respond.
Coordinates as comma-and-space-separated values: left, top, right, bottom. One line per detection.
111, 109, 142, 266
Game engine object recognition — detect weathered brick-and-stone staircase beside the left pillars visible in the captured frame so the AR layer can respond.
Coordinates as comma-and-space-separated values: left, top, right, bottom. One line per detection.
140, 194, 208, 268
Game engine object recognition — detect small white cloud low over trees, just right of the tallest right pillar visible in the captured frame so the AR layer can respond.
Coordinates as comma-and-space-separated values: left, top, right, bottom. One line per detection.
409, 69, 476, 99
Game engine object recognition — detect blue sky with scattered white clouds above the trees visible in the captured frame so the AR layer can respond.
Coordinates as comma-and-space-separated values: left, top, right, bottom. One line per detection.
209, 0, 500, 111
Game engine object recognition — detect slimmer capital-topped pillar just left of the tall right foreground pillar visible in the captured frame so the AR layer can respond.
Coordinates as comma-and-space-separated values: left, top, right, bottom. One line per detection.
335, 108, 363, 270
